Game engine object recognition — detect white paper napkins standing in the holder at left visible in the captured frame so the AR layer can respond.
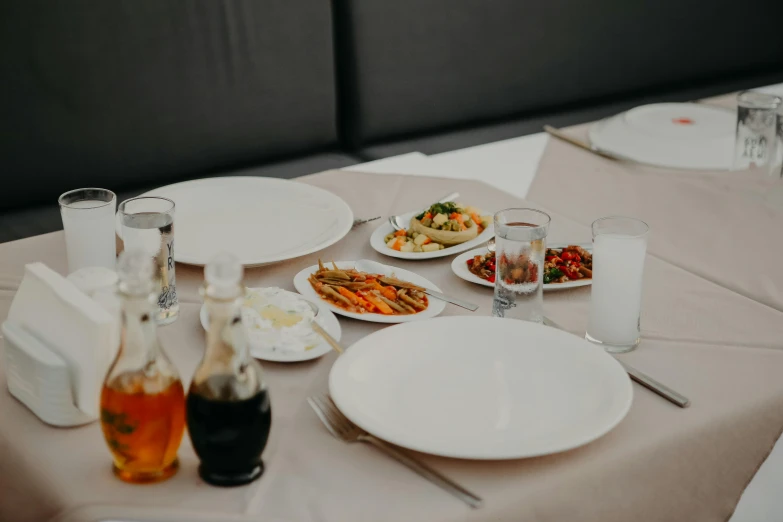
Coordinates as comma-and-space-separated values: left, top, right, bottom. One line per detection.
8, 263, 117, 418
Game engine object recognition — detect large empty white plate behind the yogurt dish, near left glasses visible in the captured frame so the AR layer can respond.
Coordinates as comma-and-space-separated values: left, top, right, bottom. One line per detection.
136, 176, 353, 266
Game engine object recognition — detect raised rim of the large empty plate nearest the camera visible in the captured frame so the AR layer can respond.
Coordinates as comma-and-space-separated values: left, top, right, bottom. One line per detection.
328, 316, 634, 461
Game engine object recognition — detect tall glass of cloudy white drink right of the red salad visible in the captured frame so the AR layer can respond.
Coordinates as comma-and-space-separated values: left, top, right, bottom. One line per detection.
585, 216, 650, 353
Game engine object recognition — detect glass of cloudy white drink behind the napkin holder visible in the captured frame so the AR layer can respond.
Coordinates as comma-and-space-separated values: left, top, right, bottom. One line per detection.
58, 188, 117, 273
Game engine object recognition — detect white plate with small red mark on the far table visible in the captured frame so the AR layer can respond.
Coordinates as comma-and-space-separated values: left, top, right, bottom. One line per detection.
588, 103, 737, 170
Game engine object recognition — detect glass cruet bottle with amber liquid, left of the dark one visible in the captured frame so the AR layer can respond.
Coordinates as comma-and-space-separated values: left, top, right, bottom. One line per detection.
101, 251, 185, 483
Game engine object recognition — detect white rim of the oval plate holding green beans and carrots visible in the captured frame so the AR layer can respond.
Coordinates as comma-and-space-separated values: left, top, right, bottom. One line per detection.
294, 261, 446, 323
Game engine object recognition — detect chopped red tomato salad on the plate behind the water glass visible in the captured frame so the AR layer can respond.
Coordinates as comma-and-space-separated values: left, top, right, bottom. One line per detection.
467, 245, 593, 285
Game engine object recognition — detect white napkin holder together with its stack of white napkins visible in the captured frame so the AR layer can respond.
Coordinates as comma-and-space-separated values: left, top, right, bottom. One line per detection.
2, 263, 118, 426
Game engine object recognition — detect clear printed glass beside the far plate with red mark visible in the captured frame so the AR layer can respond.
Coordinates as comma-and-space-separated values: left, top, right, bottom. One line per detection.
734, 91, 783, 175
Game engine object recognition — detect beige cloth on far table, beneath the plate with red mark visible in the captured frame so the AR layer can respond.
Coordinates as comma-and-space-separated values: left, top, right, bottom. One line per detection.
528, 96, 783, 310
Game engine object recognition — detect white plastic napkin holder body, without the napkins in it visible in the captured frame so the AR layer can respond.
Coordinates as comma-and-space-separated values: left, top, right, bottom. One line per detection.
2, 321, 96, 427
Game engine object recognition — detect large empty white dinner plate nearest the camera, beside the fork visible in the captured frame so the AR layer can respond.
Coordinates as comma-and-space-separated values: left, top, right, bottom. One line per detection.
329, 316, 633, 459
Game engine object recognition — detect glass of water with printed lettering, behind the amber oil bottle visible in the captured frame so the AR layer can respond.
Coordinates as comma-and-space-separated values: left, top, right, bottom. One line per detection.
117, 196, 179, 325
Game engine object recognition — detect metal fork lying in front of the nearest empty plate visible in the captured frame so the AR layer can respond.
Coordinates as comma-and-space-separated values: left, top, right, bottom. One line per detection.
307, 395, 484, 509
